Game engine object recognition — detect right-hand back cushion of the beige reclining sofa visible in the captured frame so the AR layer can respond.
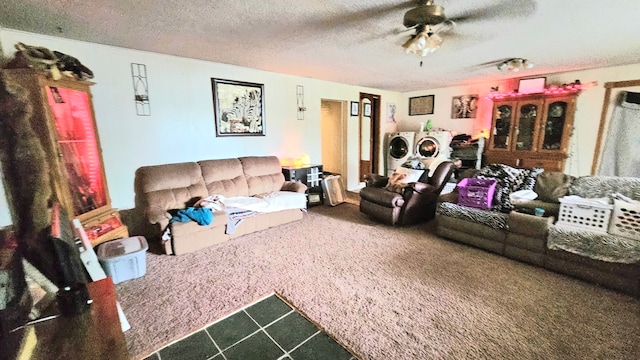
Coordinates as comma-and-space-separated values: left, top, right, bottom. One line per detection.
238, 156, 284, 196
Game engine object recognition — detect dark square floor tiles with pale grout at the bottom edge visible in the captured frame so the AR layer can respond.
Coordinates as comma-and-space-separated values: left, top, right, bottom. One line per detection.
142, 294, 356, 360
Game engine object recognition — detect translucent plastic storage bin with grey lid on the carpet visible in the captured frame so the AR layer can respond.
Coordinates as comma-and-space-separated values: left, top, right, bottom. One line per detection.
97, 236, 149, 284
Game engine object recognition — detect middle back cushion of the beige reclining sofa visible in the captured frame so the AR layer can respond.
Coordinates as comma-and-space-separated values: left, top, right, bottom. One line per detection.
198, 159, 249, 197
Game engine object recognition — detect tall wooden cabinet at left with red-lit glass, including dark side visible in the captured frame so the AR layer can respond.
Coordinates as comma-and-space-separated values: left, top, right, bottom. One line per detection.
0, 69, 128, 246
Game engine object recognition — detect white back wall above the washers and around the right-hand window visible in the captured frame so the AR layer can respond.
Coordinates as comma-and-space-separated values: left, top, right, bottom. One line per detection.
398, 64, 640, 176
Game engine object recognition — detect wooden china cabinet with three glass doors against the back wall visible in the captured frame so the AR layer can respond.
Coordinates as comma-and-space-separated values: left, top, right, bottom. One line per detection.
484, 93, 577, 171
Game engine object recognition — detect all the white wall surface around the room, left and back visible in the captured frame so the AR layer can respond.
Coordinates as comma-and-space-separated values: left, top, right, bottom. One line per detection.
0, 28, 640, 226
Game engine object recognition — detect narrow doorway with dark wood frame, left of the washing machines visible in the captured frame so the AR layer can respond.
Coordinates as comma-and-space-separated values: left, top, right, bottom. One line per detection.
358, 93, 380, 182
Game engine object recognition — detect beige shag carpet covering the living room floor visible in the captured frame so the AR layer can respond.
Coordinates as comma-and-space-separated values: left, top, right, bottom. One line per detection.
116, 203, 640, 360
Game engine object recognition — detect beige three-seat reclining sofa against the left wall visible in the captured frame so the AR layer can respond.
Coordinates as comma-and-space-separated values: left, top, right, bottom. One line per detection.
135, 156, 307, 255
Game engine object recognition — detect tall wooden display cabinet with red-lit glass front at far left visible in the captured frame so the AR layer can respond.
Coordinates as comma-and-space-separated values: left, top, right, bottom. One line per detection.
3, 69, 128, 246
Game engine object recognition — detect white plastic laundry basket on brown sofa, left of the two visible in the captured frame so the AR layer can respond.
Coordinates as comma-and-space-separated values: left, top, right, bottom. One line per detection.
556, 198, 613, 233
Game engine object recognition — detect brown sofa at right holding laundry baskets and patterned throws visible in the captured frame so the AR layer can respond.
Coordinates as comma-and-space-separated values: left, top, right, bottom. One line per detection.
436, 172, 640, 296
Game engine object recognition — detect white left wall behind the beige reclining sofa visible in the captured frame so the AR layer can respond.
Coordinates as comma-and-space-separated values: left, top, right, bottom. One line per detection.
0, 29, 400, 226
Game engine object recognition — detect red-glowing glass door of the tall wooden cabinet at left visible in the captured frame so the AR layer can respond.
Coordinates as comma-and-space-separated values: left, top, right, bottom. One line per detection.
46, 86, 108, 216
